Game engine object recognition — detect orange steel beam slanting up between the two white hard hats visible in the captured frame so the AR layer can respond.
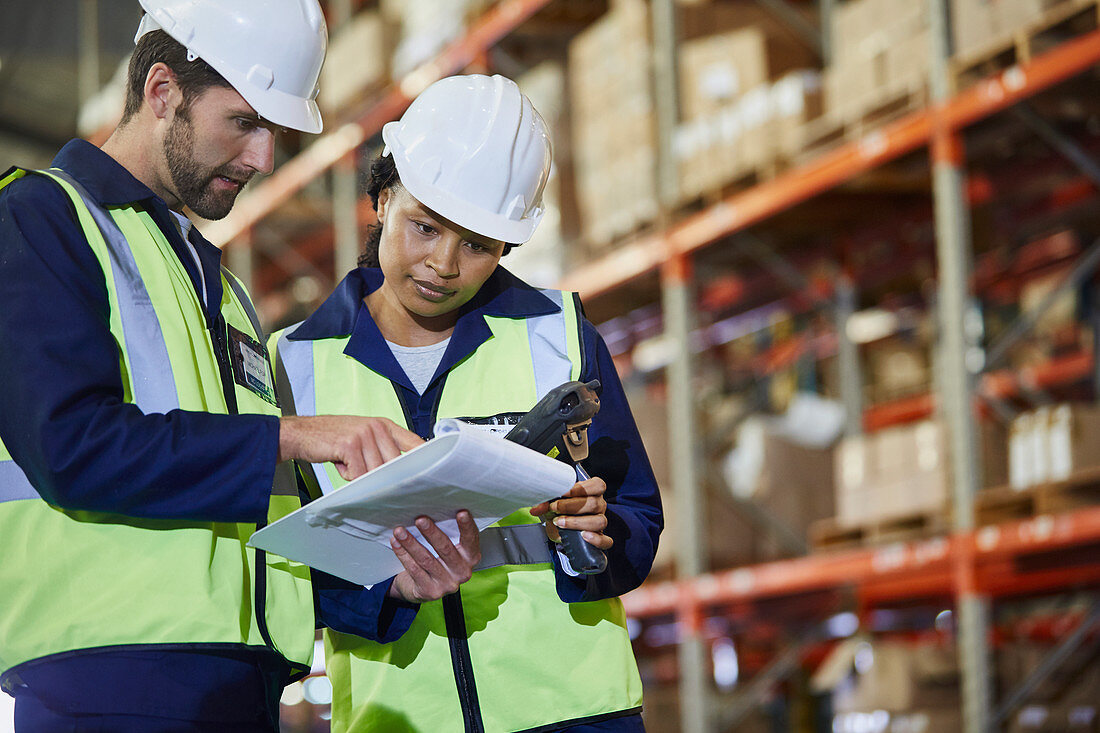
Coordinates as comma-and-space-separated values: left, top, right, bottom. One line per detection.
204, 0, 550, 247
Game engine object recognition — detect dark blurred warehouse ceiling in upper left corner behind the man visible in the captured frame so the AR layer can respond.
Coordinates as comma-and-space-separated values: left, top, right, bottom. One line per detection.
0, 0, 141, 169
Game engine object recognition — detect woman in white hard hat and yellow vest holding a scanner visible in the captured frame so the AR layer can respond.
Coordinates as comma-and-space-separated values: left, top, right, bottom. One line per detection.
273, 76, 662, 733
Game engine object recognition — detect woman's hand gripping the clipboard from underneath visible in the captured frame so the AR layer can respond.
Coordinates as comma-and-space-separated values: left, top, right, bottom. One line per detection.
389, 511, 481, 603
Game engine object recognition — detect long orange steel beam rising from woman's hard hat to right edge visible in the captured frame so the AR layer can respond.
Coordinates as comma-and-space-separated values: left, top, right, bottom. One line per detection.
562, 31, 1100, 297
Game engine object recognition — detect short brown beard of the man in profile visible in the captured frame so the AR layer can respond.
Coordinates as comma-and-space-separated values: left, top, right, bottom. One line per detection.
164, 109, 251, 220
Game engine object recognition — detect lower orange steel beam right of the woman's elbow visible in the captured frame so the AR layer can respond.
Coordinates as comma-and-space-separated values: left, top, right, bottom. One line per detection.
623, 506, 1100, 617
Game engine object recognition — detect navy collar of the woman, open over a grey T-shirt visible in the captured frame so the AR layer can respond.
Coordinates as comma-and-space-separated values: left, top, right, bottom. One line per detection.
286, 266, 561, 400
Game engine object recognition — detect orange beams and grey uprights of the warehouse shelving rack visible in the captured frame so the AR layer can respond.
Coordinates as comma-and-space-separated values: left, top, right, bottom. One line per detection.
189, 0, 1100, 733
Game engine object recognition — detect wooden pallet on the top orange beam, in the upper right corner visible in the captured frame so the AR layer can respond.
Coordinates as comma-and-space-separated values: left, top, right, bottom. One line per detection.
949, 0, 1100, 89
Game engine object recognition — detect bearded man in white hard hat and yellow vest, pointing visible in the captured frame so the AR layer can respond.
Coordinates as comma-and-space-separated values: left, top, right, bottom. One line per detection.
0, 0, 479, 732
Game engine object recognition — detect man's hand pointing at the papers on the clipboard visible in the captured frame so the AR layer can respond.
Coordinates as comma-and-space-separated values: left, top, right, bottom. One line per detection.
278, 415, 424, 481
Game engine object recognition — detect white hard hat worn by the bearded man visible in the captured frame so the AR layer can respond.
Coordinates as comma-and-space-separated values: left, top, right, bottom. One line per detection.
134, 0, 329, 133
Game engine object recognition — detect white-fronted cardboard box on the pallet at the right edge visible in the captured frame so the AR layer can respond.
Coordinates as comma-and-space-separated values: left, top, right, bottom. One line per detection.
1009, 404, 1100, 491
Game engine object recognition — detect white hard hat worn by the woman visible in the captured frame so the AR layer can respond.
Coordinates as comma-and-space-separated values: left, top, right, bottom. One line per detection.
382, 74, 553, 244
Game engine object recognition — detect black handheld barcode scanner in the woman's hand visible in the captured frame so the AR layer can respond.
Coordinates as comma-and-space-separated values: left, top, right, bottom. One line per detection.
504, 380, 607, 576
